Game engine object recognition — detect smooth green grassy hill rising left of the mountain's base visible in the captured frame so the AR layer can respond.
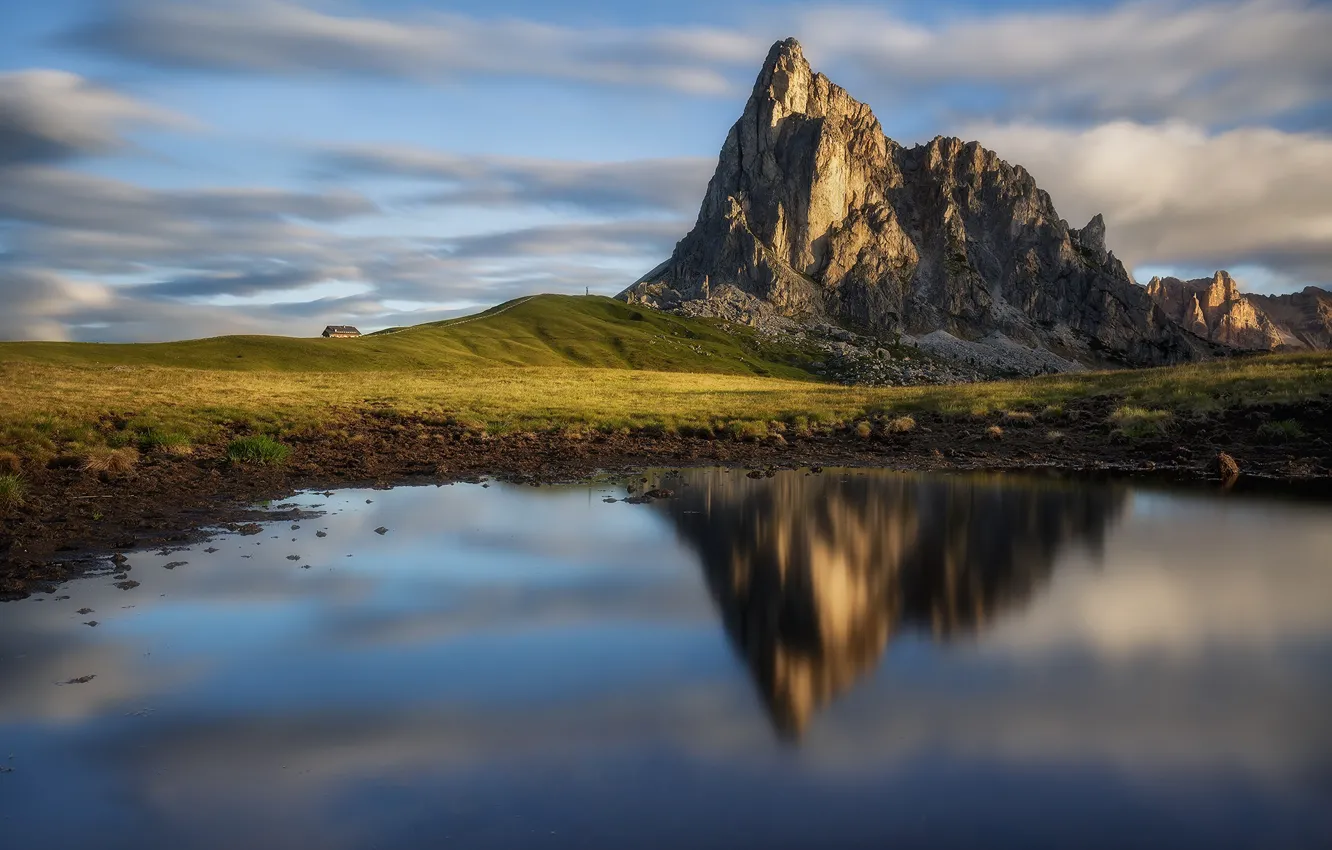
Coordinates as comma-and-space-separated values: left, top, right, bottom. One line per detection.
0, 294, 817, 378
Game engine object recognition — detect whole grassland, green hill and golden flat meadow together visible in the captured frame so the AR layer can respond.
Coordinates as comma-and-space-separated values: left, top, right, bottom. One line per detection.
0, 296, 1332, 472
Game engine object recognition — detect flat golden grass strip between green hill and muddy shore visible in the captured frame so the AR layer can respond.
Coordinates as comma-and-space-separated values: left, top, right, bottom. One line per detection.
0, 346, 1332, 466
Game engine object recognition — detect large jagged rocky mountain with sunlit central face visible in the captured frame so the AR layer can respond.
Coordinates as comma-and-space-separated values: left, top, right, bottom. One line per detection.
621, 40, 1209, 365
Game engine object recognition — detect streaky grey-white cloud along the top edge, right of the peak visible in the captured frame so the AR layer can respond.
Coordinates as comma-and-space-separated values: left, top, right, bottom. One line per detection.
798, 0, 1332, 125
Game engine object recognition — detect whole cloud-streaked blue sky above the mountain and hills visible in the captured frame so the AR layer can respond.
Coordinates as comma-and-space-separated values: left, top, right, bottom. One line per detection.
0, 0, 1332, 340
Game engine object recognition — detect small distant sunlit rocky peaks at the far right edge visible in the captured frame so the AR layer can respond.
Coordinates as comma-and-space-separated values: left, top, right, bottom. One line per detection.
1147, 272, 1332, 350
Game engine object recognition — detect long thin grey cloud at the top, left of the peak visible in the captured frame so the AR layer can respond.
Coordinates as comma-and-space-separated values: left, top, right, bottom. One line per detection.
72, 0, 763, 93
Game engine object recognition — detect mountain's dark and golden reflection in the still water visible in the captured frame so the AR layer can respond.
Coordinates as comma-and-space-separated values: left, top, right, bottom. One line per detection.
657, 470, 1127, 738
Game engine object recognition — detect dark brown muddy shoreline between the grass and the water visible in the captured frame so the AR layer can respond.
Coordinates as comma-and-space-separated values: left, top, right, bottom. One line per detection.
0, 400, 1332, 600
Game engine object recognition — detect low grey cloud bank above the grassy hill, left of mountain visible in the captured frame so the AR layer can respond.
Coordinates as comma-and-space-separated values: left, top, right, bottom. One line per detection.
0, 167, 685, 341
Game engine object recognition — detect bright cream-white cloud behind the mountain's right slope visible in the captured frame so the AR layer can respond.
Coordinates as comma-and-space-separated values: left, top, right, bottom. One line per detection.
966, 121, 1332, 290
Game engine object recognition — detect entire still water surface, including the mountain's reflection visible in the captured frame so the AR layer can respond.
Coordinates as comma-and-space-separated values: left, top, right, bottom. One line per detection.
0, 469, 1332, 850
